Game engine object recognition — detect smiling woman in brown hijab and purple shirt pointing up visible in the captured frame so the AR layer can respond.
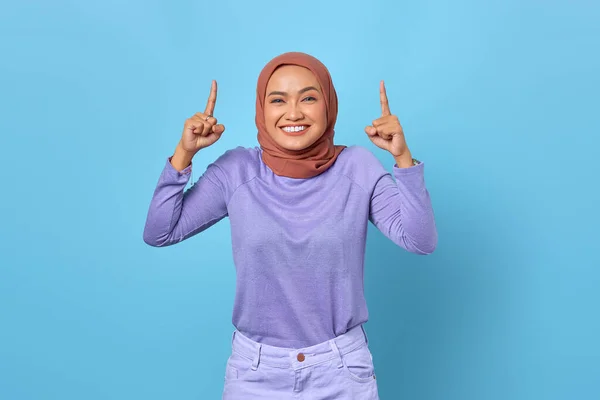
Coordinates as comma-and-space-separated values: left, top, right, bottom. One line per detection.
144, 53, 437, 400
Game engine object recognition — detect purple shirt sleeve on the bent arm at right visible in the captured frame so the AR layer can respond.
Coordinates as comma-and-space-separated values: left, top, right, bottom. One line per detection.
370, 163, 438, 254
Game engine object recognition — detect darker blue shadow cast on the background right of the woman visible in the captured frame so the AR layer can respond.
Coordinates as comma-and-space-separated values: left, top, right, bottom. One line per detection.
365, 166, 525, 400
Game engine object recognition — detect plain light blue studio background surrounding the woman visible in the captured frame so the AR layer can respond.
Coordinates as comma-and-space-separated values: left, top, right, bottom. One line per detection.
0, 0, 600, 400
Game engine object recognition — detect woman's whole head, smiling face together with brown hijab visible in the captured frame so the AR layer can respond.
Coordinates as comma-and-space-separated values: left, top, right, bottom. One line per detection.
256, 53, 345, 178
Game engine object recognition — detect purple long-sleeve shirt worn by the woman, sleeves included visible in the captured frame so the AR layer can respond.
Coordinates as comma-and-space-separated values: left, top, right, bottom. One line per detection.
144, 146, 437, 348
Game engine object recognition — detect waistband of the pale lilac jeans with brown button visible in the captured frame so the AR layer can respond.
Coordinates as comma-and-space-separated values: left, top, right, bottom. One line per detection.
231, 325, 368, 369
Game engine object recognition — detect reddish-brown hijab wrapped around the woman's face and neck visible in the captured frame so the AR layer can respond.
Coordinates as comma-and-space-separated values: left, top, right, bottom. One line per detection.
256, 52, 346, 178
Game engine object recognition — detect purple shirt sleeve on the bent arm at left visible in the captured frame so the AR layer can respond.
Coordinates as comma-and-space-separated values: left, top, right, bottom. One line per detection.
143, 158, 227, 247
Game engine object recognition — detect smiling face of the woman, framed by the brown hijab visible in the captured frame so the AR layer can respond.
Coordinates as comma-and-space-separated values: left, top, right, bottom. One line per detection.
264, 65, 327, 150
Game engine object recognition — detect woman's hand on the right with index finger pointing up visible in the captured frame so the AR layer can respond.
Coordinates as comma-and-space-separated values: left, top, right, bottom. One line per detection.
365, 81, 412, 160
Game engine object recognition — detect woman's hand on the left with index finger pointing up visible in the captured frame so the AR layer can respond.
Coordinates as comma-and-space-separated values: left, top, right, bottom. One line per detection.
179, 80, 225, 155
